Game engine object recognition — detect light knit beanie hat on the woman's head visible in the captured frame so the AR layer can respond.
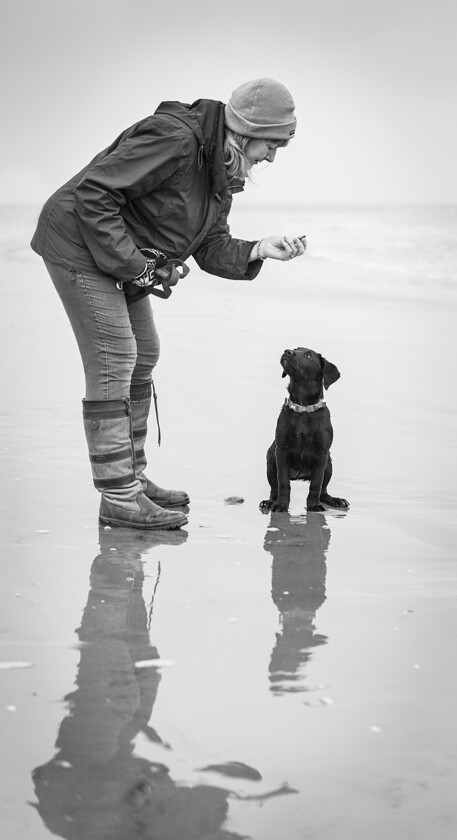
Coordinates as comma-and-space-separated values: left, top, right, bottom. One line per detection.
225, 79, 297, 140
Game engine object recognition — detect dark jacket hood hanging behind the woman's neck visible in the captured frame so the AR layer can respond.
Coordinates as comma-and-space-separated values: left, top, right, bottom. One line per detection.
155, 99, 240, 195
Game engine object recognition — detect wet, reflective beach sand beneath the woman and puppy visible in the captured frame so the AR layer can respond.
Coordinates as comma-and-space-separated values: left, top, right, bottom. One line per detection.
0, 225, 457, 840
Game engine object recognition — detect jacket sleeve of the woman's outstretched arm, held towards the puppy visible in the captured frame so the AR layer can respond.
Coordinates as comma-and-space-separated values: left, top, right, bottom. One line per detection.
192, 196, 263, 280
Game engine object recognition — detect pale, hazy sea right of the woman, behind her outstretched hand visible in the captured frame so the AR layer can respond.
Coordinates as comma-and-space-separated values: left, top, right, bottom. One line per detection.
235, 205, 457, 294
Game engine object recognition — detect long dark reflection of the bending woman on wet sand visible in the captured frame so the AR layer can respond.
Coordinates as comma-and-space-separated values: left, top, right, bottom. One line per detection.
33, 530, 242, 840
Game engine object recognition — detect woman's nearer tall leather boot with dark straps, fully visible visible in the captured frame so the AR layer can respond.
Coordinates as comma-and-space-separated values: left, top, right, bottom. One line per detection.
83, 397, 187, 530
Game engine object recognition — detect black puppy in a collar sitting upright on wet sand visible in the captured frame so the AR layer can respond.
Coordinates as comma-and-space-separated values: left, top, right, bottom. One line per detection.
260, 347, 349, 512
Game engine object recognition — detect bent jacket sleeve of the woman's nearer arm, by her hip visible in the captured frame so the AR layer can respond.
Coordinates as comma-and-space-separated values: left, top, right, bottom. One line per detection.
74, 120, 190, 280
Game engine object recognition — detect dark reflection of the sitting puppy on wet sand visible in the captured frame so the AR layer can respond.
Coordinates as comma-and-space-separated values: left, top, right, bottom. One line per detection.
264, 513, 330, 693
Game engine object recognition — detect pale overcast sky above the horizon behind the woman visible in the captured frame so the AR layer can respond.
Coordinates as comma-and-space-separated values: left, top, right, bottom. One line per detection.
0, 0, 457, 205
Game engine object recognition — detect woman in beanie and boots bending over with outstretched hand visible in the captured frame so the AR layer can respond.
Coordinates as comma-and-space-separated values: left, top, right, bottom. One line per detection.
31, 79, 304, 529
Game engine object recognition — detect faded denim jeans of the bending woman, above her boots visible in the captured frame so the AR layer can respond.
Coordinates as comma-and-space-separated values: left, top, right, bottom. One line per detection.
45, 260, 160, 400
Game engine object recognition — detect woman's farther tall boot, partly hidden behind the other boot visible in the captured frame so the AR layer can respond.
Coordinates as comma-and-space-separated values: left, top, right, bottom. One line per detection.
130, 382, 190, 507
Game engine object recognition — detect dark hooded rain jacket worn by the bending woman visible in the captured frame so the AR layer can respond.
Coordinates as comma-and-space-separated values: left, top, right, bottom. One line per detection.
31, 99, 262, 280
